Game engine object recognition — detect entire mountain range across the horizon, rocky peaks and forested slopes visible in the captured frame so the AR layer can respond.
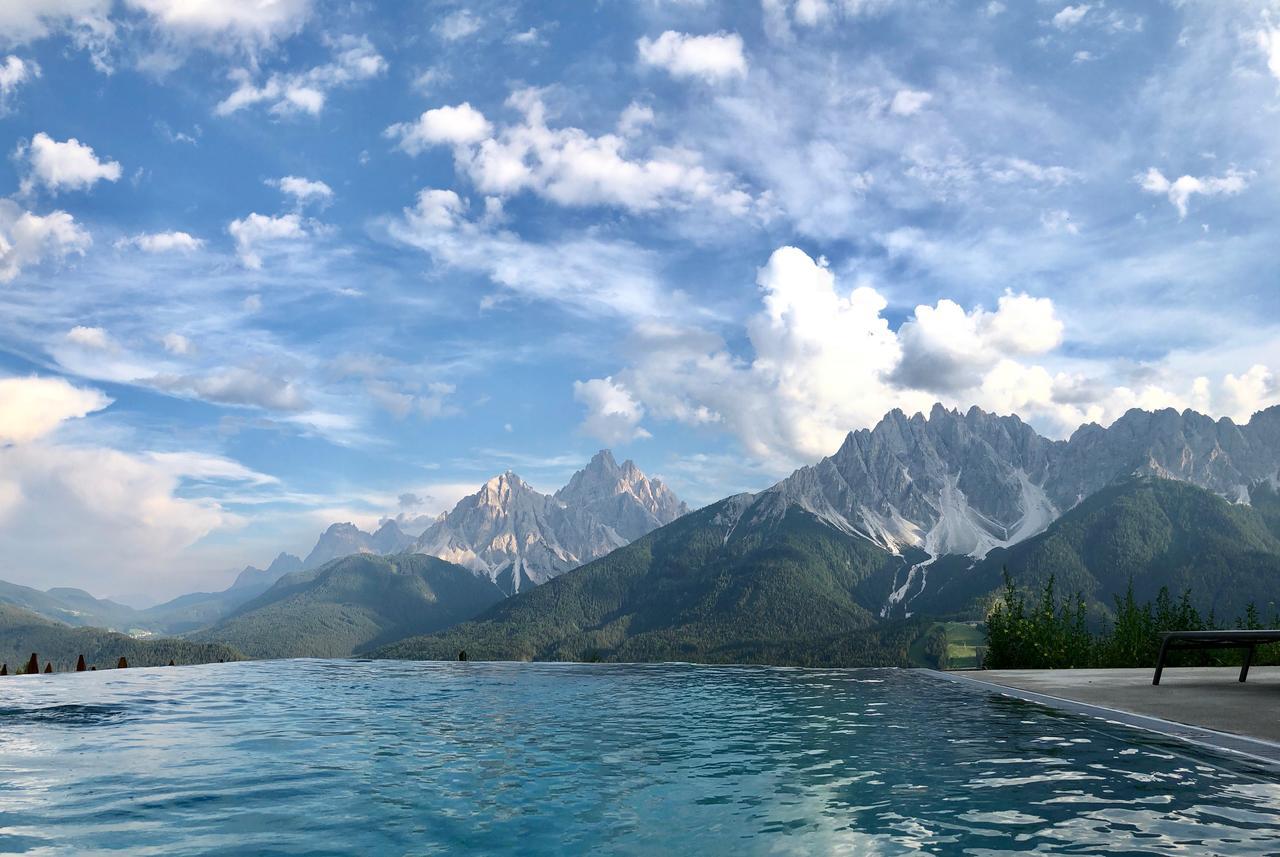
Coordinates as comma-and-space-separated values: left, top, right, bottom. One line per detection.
0, 407, 1280, 664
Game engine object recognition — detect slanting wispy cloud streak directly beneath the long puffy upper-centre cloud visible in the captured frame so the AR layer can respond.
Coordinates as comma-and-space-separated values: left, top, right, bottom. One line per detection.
387, 188, 681, 317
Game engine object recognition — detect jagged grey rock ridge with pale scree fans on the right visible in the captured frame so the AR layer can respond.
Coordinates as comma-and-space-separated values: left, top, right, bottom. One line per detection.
739, 405, 1280, 567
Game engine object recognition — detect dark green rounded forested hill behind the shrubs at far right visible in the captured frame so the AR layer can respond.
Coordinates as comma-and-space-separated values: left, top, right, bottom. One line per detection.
911, 478, 1280, 620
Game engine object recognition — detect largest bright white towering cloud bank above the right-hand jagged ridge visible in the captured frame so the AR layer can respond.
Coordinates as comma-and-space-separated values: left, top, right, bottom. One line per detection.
575, 247, 1244, 468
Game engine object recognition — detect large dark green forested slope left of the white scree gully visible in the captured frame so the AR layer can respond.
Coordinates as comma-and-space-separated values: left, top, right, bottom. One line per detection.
375, 498, 913, 664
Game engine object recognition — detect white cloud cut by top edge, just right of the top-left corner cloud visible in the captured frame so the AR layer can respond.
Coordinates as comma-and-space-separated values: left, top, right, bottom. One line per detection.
125, 0, 311, 47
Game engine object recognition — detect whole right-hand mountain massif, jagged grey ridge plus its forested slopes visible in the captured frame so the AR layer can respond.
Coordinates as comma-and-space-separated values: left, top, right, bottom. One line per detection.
379, 407, 1280, 663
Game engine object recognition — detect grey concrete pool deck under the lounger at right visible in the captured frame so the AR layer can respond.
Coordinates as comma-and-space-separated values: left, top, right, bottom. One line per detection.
931, 666, 1280, 764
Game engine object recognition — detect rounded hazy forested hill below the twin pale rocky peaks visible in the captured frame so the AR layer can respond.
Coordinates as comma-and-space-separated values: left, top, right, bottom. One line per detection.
188, 554, 503, 657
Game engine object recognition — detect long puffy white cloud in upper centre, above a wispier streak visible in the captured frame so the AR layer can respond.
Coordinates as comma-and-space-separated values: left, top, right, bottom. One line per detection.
385, 90, 755, 215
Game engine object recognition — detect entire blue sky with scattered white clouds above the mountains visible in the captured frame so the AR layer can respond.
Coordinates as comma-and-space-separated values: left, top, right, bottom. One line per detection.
0, 0, 1280, 600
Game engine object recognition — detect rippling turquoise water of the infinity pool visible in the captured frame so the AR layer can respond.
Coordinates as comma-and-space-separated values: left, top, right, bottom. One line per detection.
0, 661, 1280, 856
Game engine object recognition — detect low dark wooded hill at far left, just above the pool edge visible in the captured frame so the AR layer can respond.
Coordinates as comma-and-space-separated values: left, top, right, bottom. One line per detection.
0, 604, 242, 674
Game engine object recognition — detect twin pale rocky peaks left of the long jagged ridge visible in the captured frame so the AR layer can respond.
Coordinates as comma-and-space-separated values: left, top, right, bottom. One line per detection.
416, 450, 689, 594
